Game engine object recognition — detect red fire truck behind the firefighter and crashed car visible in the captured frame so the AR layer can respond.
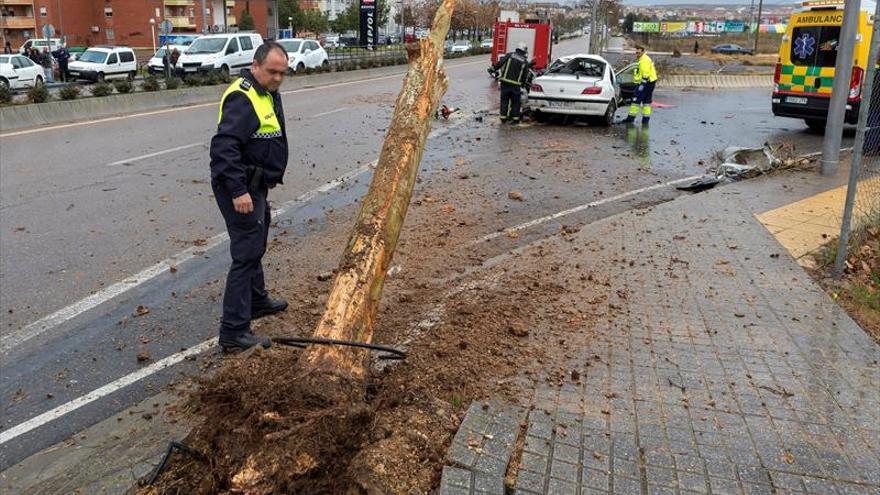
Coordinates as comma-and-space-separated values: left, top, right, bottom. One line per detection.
492, 18, 553, 70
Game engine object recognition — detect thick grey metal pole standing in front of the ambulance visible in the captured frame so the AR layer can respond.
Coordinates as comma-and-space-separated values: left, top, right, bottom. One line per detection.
822, 0, 860, 175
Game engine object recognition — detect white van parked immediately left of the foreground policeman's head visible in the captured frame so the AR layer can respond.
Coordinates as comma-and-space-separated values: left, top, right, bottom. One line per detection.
177, 33, 263, 75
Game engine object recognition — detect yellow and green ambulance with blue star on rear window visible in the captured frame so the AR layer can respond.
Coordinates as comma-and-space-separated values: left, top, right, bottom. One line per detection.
771, 0, 875, 132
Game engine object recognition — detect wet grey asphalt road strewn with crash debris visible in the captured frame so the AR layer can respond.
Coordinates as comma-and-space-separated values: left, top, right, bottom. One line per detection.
0, 35, 852, 469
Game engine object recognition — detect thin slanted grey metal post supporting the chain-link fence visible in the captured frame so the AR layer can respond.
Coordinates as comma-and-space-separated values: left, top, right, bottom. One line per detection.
833, 2, 880, 280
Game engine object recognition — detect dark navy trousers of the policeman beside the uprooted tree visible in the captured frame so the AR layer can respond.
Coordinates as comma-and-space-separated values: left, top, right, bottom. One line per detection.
212, 182, 271, 335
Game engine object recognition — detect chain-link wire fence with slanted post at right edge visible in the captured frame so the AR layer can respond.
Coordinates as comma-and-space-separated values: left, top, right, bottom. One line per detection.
834, 0, 880, 284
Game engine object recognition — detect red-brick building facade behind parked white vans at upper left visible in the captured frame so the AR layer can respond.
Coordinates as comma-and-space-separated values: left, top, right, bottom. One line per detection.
0, 0, 277, 48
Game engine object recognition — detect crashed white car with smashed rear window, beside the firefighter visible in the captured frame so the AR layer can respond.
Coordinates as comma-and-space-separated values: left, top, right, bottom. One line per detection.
529, 54, 620, 126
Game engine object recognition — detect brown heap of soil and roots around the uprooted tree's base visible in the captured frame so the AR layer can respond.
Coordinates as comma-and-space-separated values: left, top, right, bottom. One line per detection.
142, 270, 576, 495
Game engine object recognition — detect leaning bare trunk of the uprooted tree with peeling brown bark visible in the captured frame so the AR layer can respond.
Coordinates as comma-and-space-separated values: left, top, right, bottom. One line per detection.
305, 0, 456, 378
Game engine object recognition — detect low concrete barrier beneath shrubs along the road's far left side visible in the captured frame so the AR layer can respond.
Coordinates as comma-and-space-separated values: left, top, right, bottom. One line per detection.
0, 65, 416, 132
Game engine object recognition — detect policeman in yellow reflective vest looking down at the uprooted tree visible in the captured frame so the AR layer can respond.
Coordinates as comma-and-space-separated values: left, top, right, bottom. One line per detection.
211, 41, 287, 351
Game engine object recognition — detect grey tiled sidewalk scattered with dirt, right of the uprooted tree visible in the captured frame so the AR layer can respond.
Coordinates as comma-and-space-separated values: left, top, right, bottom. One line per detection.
441, 171, 880, 494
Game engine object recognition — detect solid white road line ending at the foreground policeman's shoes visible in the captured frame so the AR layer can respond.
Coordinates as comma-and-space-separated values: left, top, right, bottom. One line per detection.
0, 338, 217, 445
